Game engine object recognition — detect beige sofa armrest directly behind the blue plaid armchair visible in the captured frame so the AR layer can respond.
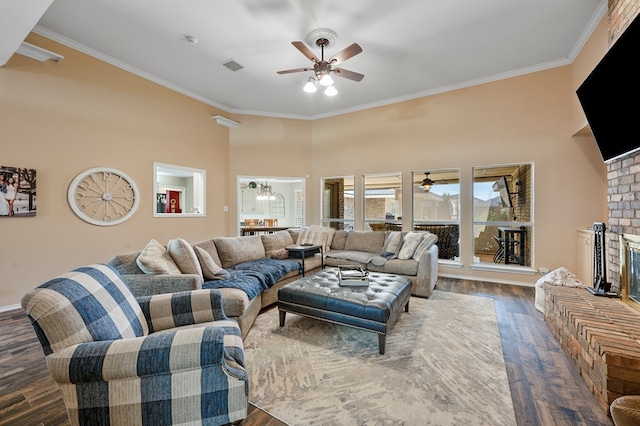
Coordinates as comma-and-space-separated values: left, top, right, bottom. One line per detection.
121, 274, 202, 297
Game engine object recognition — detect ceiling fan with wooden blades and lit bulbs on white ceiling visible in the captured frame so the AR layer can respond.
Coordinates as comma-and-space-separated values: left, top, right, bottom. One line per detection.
278, 28, 364, 92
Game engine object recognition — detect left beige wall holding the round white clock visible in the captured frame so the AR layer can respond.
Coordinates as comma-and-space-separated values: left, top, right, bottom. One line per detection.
0, 35, 229, 306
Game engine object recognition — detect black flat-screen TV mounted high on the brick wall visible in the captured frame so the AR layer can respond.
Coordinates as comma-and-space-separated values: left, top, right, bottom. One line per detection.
576, 12, 640, 161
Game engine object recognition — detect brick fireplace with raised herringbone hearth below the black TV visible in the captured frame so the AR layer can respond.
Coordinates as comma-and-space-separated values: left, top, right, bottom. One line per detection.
544, 0, 640, 411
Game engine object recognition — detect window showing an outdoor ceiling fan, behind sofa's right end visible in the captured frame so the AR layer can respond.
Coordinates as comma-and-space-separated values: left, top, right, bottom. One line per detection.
412, 169, 460, 261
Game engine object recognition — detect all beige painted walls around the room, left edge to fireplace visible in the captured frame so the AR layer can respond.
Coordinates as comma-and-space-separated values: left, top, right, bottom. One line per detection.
0, 13, 606, 307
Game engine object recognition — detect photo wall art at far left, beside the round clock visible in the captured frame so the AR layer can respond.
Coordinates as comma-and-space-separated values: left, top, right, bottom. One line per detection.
0, 166, 36, 217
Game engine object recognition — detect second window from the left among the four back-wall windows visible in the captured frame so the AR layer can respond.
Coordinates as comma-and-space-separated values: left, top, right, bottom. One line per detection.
363, 173, 402, 231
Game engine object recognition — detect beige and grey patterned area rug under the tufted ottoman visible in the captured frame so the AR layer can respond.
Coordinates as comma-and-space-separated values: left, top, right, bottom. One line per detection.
245, 290, 516, 426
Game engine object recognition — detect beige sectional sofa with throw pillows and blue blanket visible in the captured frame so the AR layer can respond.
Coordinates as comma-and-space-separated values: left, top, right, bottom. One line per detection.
108, 226, 438, 337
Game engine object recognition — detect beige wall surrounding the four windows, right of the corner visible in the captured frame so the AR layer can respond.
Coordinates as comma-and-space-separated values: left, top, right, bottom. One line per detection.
311, 66, 606, 283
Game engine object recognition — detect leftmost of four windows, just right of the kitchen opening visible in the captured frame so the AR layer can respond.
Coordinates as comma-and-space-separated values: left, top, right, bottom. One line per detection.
322, 176, 354, 230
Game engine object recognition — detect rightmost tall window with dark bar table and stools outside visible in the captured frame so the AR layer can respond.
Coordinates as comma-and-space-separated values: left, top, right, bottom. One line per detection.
473, 164, 533, 266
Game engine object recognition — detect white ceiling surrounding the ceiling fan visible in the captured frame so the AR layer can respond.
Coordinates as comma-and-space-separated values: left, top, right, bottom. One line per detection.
8, 0, 607, 119
